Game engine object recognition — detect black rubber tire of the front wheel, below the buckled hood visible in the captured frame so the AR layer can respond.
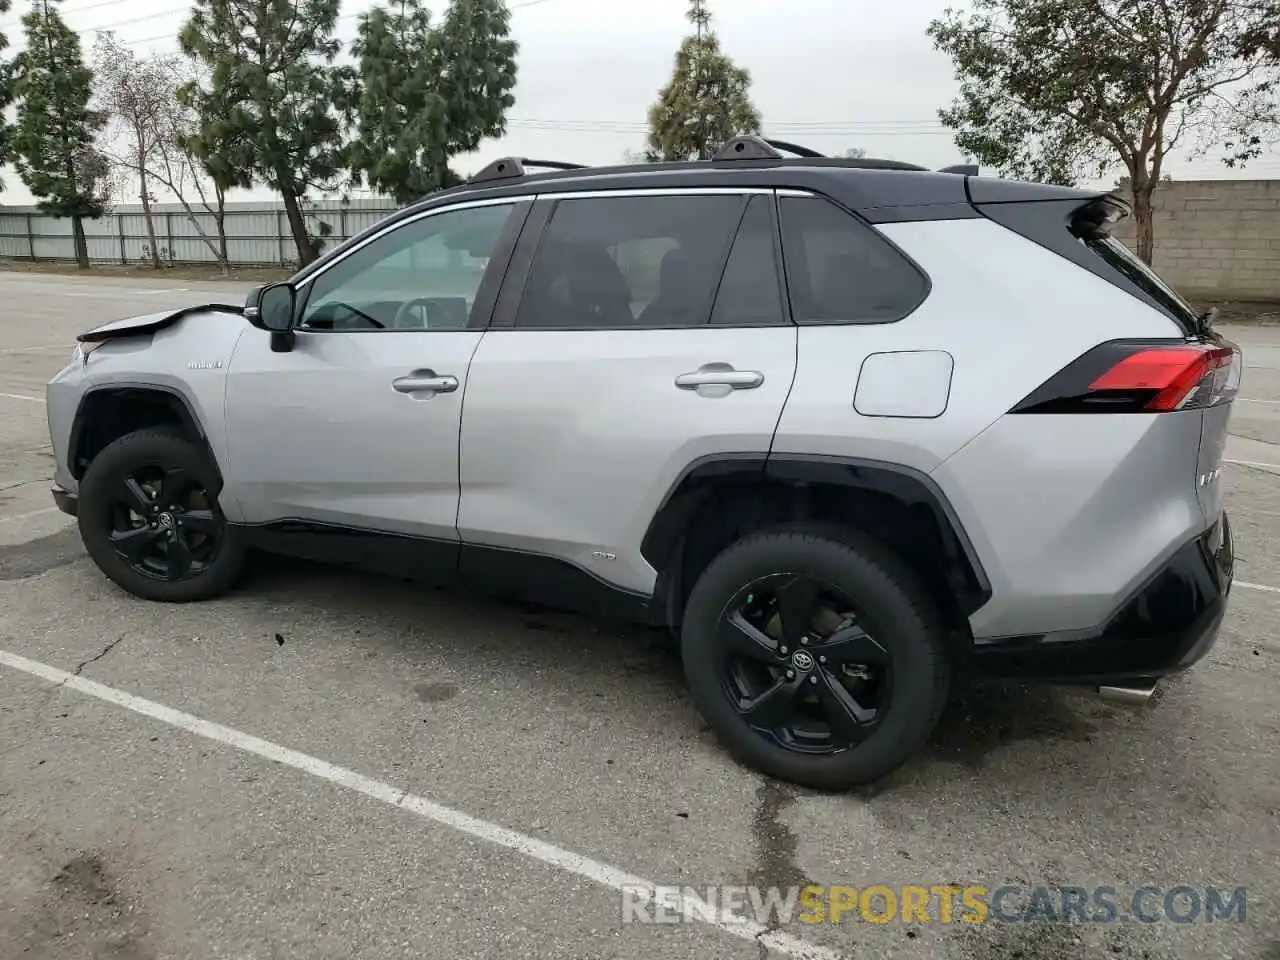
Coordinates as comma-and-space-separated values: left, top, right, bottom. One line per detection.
77, 428, 246, 603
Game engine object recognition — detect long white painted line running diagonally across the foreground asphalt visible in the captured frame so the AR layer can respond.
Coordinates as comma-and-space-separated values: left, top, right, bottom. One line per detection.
0, 650, 842, 960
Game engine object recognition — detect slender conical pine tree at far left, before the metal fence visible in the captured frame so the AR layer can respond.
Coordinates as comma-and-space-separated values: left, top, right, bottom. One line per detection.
13, 0, 106, 269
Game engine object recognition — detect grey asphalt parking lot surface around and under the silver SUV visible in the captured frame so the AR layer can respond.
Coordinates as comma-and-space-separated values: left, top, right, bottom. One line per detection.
0, 274, 1280, 960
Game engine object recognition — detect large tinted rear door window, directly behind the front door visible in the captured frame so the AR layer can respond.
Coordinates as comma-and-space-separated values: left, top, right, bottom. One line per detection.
516, 196, 746, 329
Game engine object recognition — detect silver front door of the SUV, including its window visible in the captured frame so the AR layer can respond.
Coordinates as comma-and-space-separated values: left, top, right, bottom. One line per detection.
224, 202, 529, 541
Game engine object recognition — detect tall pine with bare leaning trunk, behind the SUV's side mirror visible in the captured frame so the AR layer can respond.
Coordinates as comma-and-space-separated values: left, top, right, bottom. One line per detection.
179, 0, 355, 264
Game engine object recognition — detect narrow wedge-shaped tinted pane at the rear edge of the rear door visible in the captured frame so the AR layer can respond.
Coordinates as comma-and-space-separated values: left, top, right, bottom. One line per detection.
712, 197, 786, 326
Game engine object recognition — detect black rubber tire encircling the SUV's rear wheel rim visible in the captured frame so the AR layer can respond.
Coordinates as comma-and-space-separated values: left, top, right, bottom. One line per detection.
681, 526, 951, 790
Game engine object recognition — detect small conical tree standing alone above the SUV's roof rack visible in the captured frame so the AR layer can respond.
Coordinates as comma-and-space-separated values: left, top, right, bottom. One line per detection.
649, 0, 760, 160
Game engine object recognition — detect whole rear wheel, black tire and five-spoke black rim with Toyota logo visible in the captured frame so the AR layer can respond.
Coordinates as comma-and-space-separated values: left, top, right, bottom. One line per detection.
681, 529, 950, 790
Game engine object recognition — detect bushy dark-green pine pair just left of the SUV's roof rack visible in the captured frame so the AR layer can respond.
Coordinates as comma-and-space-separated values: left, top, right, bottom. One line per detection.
351, 0, 517, 204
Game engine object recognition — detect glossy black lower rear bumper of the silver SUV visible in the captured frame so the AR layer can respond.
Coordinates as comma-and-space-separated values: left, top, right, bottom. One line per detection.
973, 513, 1235, 686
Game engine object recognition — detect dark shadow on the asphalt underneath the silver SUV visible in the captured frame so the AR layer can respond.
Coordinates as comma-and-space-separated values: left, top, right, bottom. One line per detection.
243, 547, 1116, 773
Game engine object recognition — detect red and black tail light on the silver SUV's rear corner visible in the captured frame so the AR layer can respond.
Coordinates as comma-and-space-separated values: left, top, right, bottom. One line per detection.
1010, 338, 1243, 413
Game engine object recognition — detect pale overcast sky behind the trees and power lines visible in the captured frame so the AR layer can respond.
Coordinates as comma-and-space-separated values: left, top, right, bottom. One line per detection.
0, 0, 1280, 204
